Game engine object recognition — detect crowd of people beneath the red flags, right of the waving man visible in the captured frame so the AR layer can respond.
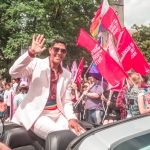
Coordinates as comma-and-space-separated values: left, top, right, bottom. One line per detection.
72, 71, 150, 125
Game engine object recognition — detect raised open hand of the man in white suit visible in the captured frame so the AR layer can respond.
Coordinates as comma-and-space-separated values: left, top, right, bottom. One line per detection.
30, 34, 46, 55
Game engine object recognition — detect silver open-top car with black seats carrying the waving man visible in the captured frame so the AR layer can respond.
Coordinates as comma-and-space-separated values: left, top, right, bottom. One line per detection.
1, 114, 150, 150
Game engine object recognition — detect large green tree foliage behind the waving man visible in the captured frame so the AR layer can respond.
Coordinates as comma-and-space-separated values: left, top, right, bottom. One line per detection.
0, 0, 113, 77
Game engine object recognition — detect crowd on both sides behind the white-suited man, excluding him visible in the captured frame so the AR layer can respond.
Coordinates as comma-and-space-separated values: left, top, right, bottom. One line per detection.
0, 68, 150, 125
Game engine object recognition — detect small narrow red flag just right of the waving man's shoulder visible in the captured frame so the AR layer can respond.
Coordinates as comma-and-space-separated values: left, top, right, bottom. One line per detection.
74, 57, 84, 87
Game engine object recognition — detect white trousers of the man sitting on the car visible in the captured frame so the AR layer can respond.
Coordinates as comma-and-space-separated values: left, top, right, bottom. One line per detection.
31, 109, 69, 139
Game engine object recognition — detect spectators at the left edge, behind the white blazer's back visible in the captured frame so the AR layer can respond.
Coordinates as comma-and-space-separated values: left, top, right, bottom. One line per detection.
0, 78, 28, 121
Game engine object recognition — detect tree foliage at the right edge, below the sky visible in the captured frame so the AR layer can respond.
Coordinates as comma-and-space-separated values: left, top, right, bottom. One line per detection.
132, 25, 150, 62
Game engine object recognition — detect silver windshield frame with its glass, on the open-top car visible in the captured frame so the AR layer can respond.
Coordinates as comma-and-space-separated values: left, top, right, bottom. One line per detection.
66, 114, 150, 150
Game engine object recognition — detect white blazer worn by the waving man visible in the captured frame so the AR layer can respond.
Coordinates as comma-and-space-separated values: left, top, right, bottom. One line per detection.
9, 52, 76, 130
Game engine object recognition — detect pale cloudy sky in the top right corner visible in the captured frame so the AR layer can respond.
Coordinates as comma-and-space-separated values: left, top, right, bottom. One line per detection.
124, 0, 150, 28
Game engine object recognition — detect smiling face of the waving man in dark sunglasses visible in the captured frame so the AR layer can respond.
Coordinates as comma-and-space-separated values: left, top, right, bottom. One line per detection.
49, 43, 67, 64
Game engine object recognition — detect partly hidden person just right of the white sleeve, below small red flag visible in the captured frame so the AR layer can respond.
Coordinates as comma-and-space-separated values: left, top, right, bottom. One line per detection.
71, 83, 81, 120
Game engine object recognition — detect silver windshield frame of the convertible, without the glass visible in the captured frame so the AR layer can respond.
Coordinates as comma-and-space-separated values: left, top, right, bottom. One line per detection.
67, 115, 150, 150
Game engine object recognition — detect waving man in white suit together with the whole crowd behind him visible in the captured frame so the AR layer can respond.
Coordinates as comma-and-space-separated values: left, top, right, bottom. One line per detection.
0, 35, 150, 142
